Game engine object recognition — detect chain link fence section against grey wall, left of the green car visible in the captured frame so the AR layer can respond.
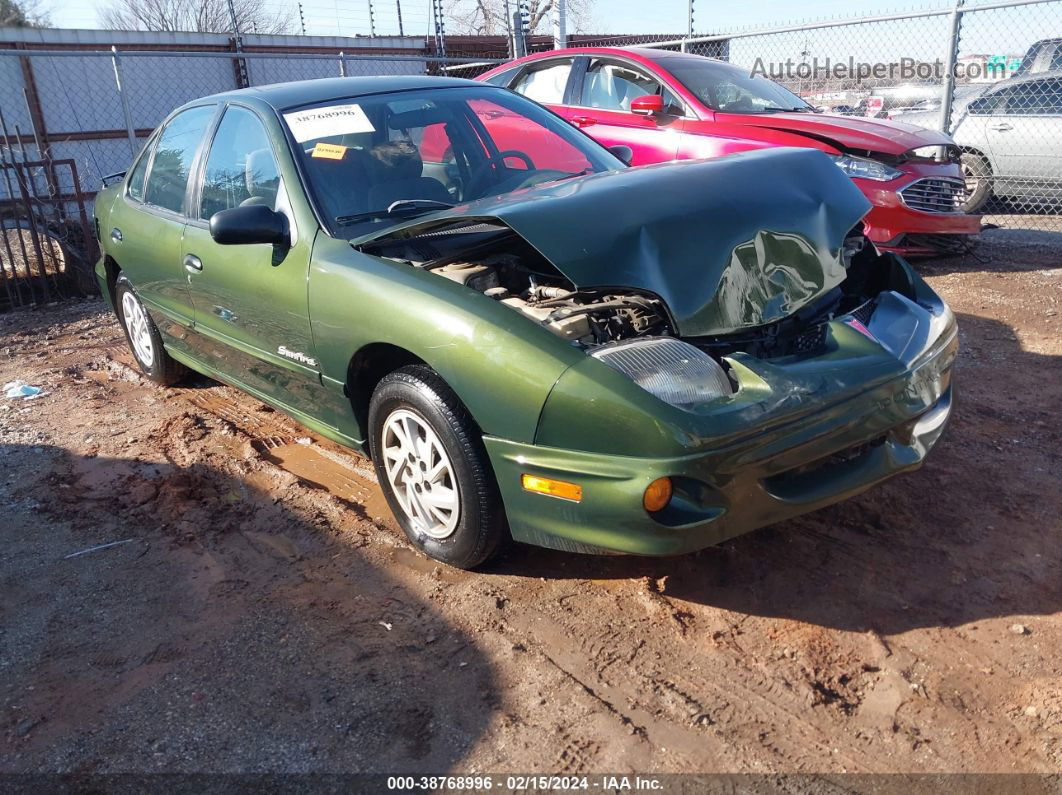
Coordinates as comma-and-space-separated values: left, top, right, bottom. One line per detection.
0, 42, 501, 309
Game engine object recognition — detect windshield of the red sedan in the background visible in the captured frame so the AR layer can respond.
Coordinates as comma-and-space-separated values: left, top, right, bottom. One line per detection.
666, 56, 813, 114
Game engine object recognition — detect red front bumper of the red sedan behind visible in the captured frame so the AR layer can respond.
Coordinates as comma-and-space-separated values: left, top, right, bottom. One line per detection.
853, 163, 981, 257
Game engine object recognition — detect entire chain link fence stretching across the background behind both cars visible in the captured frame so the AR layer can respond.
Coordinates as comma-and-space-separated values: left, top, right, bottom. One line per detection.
0, 0, 1062, 307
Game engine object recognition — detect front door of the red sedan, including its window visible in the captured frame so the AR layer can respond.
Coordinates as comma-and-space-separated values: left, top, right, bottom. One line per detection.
559, 57, 684, 166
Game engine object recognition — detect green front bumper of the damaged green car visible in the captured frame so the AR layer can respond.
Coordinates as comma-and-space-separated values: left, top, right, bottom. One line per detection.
484, 288, 958, 555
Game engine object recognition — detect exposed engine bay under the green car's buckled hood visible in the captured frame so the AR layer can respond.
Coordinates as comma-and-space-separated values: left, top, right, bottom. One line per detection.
365, 222, 905, 360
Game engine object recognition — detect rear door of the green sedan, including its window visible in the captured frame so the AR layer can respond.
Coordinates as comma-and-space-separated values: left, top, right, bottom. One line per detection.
107, 104, 217, 341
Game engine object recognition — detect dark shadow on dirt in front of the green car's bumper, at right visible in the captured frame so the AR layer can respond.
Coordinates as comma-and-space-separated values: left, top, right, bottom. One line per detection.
495, 315, 1062, 635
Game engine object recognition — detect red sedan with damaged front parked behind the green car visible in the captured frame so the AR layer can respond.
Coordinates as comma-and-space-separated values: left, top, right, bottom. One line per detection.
478, 47, 980, 256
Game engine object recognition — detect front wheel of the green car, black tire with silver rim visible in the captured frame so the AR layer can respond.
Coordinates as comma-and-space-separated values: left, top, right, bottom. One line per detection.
369, 365, 507, 569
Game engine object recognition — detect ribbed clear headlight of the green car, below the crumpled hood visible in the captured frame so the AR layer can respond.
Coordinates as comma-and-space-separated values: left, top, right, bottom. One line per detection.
590, 338, 734, 411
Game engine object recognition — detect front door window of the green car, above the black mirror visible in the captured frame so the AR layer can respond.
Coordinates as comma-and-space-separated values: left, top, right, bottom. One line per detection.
199, 106, 280, 219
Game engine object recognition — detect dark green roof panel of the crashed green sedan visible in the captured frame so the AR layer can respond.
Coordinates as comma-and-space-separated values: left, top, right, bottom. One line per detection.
197, 74, 483, 110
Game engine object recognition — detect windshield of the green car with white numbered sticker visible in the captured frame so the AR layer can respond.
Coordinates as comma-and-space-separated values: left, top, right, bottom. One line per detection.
284, 86, 624, 238
